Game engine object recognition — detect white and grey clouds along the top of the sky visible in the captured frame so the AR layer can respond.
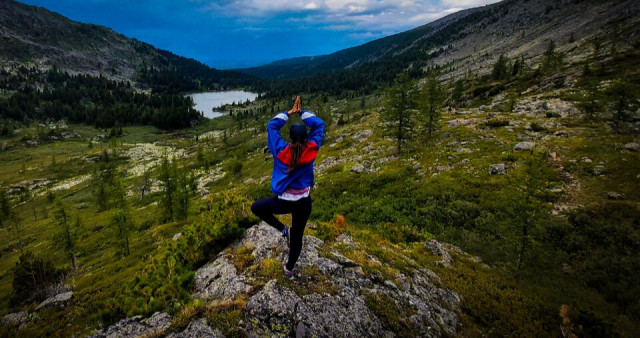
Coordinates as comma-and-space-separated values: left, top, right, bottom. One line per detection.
200, 0, 498, 34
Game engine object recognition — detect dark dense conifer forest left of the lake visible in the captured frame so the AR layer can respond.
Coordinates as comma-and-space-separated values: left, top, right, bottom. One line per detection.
0, 67, 201, 129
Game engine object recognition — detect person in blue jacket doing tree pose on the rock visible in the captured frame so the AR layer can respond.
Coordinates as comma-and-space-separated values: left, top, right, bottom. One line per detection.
251, 96, 324, 278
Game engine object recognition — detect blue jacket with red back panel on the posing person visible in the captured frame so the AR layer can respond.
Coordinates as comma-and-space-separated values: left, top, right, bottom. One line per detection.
267, 110, 324, 196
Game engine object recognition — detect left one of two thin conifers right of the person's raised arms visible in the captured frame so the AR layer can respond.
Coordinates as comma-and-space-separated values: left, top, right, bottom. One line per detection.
380, 72, 413, 155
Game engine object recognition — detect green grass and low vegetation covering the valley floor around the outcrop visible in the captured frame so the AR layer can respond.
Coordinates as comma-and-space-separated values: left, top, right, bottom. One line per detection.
0, 74, 640, 336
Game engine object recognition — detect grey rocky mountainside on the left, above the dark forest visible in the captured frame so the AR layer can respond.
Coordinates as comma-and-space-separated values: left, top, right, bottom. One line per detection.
0, 0, 253, 86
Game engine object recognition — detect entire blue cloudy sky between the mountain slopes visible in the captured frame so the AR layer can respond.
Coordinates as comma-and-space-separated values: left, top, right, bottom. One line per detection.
20, 0, 499, 69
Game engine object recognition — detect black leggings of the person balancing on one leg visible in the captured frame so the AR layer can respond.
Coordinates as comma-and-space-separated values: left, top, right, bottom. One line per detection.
251, 197, 311, 271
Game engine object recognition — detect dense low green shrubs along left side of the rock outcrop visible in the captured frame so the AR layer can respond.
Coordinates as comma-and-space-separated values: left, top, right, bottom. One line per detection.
110, 193, 255, 321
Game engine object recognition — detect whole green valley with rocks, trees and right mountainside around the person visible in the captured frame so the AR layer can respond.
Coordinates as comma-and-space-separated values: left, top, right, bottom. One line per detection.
0, 0, 640, 337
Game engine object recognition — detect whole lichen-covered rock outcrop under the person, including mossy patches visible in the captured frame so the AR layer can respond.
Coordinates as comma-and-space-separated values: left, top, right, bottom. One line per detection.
94, 223, 461, 337
